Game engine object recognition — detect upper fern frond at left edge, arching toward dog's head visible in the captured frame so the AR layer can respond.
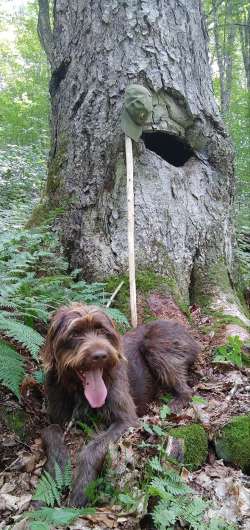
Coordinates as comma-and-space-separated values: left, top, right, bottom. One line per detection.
0, 314, 44, 360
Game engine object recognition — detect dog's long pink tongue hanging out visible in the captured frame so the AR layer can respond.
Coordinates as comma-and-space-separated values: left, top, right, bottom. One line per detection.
84, 368, 107, 409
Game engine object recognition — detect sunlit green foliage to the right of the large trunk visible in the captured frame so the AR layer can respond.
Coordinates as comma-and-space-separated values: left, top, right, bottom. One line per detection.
203, 0, 250, 289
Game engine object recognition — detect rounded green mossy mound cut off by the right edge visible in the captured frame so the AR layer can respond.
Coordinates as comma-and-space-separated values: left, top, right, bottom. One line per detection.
215, 415, 250, 474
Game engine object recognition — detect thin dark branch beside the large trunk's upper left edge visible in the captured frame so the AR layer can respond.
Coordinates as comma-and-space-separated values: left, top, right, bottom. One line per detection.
37, 0, 55, 65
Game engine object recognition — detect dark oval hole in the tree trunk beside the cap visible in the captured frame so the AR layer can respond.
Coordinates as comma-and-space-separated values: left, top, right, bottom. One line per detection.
142, 131, 194, 167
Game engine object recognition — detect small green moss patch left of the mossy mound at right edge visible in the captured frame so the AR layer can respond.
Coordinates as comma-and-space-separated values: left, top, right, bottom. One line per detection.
168, 423, 208, 471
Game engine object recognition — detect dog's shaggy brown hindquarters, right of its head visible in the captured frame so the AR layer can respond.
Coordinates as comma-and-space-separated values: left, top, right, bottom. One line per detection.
123, 320, 200, 415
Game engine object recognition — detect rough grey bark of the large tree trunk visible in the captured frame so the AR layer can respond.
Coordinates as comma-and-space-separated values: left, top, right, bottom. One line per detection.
39, 0, 249, 322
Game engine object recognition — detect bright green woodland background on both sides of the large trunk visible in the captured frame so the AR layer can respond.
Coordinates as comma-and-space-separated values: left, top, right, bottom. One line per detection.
0, 0, 250, 276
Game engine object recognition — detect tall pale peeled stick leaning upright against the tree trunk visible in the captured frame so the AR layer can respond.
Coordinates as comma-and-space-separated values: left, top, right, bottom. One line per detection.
125, 135, 137, 328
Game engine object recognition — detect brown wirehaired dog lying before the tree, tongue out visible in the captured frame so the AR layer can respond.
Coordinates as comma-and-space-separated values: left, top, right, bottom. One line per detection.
42, 303, 199, 506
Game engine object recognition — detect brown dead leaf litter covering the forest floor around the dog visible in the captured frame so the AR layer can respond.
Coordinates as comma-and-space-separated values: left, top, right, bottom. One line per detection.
0, 295, 250, 530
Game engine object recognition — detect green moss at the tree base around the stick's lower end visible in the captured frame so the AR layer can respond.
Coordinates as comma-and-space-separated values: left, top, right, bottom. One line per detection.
106, 270, 188, 322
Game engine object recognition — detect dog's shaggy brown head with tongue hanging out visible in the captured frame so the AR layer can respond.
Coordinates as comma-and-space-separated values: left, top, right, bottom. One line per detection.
42, 303, 123, 408
